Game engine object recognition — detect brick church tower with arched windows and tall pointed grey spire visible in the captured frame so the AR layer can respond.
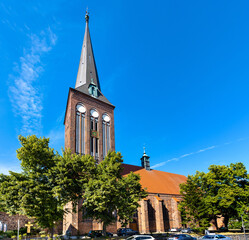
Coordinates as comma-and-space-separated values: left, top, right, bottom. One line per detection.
64, 10, 115, 163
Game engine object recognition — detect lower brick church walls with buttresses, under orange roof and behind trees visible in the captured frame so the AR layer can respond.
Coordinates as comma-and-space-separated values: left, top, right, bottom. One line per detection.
63, 193, 181, 235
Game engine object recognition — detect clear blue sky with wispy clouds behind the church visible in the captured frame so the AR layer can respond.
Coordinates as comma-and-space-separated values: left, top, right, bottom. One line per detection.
0, 0, 249, 175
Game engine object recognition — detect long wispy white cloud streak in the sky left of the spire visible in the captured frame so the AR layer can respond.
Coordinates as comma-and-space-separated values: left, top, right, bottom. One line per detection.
9, 28, 57, 135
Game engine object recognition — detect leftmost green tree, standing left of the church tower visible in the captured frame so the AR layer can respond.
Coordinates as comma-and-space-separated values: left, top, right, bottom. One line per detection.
0, 135, 63, 235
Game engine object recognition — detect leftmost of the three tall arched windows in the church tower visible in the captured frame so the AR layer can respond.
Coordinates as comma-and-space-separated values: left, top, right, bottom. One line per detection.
75, 103, 86, 154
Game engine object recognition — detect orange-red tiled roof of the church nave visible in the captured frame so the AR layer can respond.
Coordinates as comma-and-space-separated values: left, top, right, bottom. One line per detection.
122, 164, 187, 195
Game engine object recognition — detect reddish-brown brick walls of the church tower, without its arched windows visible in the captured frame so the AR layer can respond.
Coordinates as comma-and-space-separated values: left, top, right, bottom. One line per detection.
63, 88, 116, 235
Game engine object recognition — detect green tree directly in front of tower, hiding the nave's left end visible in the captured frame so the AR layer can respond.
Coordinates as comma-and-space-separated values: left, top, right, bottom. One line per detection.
82, 152, 147, 233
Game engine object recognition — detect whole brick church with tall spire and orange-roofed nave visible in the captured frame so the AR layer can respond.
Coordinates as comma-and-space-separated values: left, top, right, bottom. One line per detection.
63, 14, 186, 235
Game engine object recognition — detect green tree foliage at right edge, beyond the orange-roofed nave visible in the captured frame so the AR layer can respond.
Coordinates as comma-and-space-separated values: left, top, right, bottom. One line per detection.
179, 163, 249, 230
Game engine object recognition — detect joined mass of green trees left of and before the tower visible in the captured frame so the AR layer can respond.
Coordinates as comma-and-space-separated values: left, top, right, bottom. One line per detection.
0, 135, 146, 235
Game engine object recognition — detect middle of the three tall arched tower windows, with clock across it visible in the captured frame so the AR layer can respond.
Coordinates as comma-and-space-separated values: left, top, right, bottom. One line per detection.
90, 109, 99, 162
